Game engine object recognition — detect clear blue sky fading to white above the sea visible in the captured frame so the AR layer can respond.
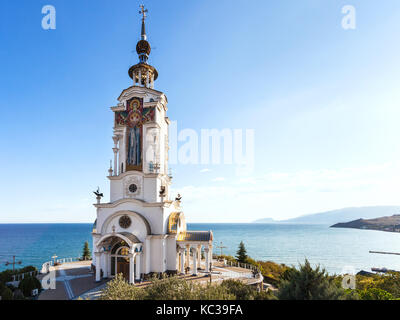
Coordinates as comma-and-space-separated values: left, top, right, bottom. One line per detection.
0, 0, 400, 223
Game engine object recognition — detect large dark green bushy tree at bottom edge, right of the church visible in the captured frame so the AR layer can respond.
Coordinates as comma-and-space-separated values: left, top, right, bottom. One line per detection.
277, 260, 347, 300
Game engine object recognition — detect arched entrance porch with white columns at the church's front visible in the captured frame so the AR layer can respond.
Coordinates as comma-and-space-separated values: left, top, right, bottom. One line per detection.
96, 233, 142, 283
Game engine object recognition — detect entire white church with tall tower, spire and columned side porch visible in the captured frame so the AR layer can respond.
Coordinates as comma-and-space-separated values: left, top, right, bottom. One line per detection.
92, 6, 213, 283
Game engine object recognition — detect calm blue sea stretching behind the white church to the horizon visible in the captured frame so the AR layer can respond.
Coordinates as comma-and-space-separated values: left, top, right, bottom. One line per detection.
0, 223, 400, 274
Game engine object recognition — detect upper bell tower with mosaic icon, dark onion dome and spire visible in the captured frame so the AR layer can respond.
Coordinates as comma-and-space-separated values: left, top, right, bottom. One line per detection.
108, 6, 171, 202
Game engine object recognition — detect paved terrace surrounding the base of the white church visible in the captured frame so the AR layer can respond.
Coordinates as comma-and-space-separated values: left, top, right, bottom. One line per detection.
39, 261, 261, 300
